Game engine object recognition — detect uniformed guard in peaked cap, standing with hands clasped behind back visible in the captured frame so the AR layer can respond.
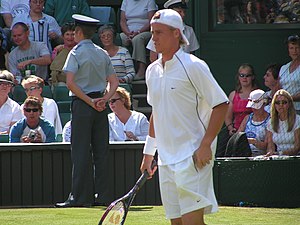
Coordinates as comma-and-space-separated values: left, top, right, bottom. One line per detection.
56, 14, 119, 207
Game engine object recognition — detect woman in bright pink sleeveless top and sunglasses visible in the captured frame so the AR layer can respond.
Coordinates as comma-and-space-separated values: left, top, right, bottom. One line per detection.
225, 63, 257, 136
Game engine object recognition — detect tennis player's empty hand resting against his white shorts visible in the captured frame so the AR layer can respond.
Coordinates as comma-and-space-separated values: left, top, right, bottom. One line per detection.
193, 145, 212, 169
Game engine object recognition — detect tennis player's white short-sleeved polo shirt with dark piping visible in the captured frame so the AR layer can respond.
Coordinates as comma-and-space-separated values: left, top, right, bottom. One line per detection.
146, 49, 228, 165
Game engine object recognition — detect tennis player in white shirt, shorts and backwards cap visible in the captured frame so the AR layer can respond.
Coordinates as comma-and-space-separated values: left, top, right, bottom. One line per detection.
141, 9, 228, 225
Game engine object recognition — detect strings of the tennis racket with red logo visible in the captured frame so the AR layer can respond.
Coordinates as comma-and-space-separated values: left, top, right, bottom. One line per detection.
102, 202, 125, 225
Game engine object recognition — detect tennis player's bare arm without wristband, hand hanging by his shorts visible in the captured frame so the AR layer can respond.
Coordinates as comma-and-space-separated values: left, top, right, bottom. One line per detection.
193, 102, 228, 168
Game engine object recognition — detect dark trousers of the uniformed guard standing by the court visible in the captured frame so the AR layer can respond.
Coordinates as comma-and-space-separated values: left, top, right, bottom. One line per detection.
71, 98, 109, 204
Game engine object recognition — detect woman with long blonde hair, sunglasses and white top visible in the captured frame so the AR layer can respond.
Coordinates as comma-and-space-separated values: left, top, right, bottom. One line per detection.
267, 89, 300, 156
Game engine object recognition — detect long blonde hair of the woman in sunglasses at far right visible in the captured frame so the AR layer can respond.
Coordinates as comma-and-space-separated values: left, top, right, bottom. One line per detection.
271, 89, 296, 133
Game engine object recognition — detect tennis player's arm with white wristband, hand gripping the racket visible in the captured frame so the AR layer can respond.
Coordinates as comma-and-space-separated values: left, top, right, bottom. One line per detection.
140, 114, 157, 178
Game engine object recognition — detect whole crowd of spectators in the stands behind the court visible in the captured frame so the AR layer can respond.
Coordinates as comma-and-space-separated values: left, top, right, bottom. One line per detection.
0, 0, 300, 156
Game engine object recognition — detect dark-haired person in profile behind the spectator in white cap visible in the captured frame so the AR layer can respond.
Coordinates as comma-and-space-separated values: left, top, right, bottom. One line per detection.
264, 64, 281, 113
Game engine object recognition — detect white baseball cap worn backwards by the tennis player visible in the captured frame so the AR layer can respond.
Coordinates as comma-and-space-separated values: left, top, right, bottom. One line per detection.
150, 9, 190, 45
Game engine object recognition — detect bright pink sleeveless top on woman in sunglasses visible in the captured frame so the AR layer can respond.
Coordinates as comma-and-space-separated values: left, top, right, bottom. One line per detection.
232, 92, 252, 129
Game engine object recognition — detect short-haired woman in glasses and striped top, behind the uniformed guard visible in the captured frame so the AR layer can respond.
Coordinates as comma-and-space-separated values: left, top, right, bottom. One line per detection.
99, 25, 135, 83
